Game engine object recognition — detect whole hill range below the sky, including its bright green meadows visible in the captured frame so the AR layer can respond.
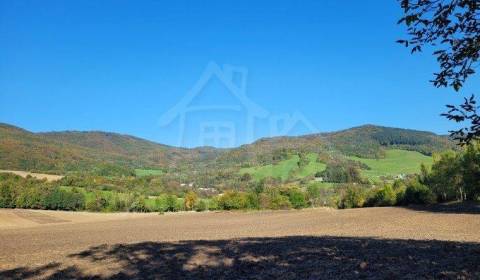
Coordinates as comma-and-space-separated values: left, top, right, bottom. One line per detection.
0, 124, 456, 183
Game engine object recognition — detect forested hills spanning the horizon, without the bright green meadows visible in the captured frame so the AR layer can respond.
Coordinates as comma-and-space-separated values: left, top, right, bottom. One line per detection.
0, 124, 456, 173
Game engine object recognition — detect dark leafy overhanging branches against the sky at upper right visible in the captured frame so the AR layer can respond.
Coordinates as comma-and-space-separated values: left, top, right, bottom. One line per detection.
398, 0, 480, 144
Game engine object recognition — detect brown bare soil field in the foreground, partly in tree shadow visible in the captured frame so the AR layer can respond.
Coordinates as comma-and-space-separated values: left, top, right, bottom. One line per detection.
0, 205, 480, 279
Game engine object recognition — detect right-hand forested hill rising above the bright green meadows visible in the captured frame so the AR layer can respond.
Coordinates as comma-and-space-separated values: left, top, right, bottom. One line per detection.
218, 125, 458, 165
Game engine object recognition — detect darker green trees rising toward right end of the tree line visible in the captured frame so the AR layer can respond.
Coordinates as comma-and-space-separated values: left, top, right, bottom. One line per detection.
335, 142, 480, 208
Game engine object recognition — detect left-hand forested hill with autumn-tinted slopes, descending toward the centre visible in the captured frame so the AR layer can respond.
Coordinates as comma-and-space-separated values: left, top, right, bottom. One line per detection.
0, 124, 219, 173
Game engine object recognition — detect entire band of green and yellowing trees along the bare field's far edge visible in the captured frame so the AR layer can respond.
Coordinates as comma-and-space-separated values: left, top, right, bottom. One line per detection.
0, 143, 480, 212
